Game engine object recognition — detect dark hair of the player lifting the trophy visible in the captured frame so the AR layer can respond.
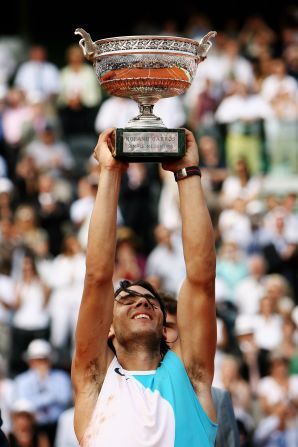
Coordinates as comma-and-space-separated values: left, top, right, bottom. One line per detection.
108, 279, 169, 357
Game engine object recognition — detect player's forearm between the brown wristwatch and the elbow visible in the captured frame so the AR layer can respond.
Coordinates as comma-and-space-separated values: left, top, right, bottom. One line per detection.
178, 175, 215, 282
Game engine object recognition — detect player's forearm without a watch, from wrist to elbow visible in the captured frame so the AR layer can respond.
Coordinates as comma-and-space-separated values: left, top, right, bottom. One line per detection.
86, 169, 121, 278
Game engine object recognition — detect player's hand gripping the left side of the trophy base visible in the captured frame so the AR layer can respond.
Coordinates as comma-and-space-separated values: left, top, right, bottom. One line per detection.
93, 127, 128, 172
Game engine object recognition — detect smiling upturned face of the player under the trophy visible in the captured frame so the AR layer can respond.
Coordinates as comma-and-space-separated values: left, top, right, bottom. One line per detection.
112, 286, 165, 347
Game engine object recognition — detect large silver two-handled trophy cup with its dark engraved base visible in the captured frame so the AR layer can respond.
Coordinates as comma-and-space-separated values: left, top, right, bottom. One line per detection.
75, 28, 216, 162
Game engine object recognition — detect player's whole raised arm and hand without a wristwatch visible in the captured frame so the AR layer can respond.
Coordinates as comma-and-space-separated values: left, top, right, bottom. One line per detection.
72, 129, 126, 387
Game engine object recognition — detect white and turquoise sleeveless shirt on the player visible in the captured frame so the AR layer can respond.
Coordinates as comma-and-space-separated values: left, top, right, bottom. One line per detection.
80, 351, 217, 447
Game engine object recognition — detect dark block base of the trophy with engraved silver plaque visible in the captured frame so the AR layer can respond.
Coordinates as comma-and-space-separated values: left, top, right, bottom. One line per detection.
113, 128, 186, 163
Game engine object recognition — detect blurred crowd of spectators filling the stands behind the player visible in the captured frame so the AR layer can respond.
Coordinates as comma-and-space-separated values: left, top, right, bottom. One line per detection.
0, 9, 298, 447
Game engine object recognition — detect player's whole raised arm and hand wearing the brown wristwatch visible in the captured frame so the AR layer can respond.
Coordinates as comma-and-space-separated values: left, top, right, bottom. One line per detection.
163, 130, 216, 419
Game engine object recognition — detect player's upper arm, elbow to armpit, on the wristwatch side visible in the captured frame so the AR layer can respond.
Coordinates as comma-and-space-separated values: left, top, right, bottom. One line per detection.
177, 279, 216, 380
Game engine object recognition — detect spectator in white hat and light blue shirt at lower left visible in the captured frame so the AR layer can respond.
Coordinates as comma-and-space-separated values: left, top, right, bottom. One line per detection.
15, 339, 72, 446
